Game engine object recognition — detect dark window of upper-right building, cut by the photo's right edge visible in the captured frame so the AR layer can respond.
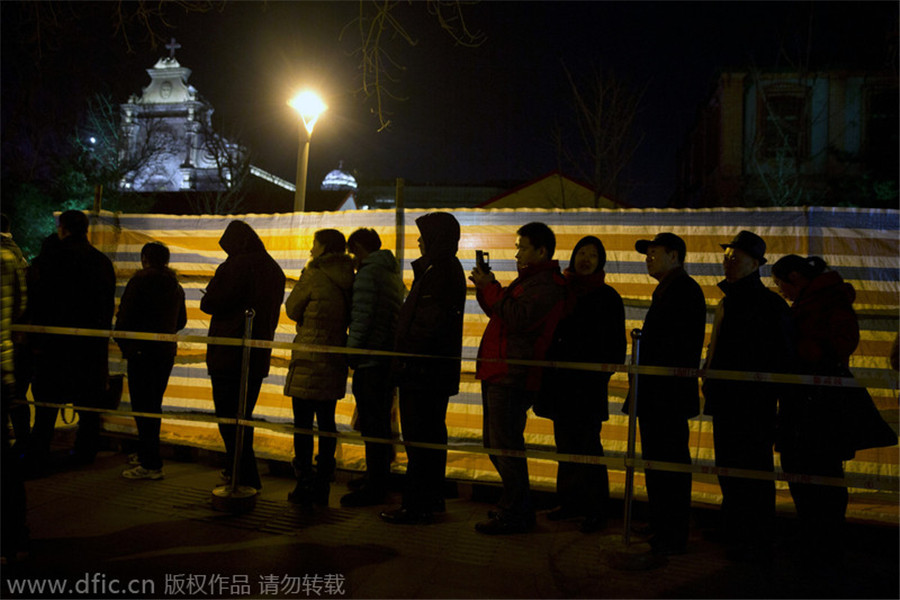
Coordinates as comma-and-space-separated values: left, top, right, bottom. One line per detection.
863, 87, 900, 176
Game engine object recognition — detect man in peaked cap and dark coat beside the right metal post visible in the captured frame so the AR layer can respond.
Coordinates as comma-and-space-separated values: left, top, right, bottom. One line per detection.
624, 232, 706, 555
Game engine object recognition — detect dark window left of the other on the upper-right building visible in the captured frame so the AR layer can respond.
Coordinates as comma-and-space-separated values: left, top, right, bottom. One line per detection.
758, 85, 810, 158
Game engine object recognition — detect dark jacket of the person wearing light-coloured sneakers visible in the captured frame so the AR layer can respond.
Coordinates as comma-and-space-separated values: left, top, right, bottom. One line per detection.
116, 267, 187, 358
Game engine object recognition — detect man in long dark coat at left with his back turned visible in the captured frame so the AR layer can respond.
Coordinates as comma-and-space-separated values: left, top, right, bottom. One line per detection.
28, 210, 116, 468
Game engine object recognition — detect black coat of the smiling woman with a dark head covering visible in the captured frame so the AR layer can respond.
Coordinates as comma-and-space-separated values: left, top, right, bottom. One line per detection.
534, 269, 627, 426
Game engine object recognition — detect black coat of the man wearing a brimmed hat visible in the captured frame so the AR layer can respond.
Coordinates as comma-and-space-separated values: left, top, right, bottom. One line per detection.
703, 271, 794, 418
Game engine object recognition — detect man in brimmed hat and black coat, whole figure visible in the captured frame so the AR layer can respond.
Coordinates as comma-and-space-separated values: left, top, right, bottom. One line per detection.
703, 231, 793, 562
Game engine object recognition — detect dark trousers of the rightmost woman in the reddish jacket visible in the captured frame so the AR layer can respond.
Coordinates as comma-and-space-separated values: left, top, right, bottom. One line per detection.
781, 449, 848, 560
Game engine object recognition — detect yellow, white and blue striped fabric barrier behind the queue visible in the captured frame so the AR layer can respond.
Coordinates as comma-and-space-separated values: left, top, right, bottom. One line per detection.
81, 208, 900, 502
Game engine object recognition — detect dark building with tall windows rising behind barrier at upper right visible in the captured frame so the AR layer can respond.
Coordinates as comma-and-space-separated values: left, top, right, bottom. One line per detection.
672, 70, 900, 208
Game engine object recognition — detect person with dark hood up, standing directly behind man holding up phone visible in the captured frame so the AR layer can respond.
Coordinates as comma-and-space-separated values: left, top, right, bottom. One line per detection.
381, 213, 466, 523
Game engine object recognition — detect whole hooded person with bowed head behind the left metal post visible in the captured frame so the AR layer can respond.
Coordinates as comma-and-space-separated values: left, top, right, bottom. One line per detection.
200, 221, 285, 489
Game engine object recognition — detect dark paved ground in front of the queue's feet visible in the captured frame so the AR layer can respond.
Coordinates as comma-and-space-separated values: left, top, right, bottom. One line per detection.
0, 436, 900, 598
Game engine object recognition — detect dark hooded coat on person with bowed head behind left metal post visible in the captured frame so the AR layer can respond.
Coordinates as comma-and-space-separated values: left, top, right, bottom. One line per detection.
200, 221, 285, 379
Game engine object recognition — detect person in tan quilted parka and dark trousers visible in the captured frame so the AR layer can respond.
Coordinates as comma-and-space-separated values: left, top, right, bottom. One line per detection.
284, 229, 353, 506
